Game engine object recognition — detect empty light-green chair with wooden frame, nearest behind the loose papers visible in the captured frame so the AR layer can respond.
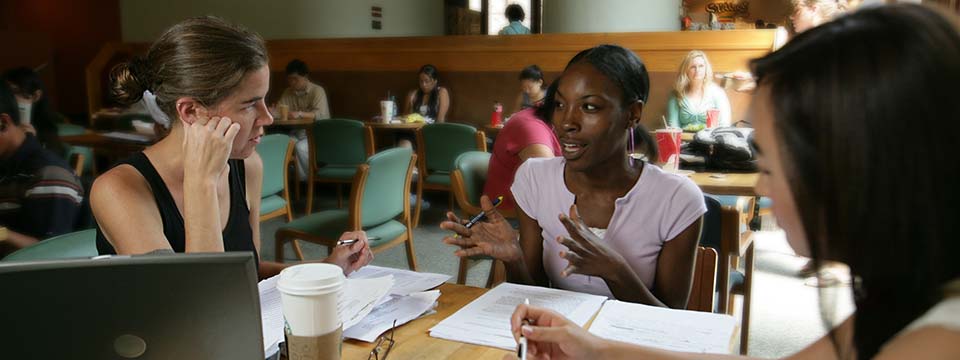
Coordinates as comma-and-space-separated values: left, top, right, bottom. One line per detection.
275, 148, 417, 270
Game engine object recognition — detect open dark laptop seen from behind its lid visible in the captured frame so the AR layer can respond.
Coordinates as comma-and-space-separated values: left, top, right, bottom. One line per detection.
0, 252, 264, 360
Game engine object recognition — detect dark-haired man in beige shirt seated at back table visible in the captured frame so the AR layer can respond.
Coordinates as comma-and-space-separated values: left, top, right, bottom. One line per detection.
273, 60, 330, 180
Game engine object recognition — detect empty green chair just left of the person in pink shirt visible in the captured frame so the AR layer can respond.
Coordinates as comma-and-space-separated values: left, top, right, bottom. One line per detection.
413, 123, 487, 226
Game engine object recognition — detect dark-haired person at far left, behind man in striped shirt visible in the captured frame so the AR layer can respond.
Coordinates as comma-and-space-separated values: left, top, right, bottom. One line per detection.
3, 67, 67, 158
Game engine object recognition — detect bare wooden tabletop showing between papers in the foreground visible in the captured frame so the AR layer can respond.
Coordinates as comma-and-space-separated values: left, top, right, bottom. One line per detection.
342, 283, 512, 360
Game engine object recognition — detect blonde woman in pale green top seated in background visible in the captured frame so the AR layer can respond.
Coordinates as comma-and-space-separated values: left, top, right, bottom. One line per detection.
667, 50, 730, 131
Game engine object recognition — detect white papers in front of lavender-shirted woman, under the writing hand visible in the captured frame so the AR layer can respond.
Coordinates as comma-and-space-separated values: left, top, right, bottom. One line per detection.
430, 283, 607, 350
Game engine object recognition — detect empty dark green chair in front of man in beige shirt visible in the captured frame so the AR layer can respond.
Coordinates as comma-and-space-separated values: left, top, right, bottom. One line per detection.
307, 119, 374, 214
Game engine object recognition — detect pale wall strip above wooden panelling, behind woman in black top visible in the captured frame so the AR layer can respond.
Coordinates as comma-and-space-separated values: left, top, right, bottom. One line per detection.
120, 0, 443, 42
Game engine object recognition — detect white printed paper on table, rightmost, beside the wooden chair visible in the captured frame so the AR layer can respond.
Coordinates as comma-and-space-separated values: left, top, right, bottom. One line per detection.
590, 300, 737, 354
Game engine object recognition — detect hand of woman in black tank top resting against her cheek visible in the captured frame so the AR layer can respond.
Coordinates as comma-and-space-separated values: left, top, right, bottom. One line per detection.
183, 108, 240, 181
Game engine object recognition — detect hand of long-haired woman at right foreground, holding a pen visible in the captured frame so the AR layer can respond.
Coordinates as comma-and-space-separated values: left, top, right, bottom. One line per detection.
504, 304, 603, 360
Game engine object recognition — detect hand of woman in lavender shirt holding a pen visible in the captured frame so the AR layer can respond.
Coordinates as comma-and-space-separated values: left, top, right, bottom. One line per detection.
440, 195, 523, 262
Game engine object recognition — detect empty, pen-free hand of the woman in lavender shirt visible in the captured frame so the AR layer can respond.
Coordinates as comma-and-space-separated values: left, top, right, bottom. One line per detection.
557, 205, 624, 277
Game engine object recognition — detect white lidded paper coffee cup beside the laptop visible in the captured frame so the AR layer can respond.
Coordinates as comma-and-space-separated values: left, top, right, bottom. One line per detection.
277, 264, 346, 336
